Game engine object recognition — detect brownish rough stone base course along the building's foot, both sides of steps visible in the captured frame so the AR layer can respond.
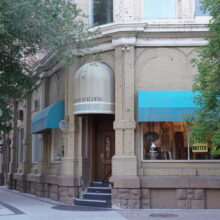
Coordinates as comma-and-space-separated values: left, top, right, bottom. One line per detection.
9, 175, 220, 209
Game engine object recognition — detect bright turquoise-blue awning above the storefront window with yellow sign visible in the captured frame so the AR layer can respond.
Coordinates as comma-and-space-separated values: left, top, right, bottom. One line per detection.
138, 90, 198, 122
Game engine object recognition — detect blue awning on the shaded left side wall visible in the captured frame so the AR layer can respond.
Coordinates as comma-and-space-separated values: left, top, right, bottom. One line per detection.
31, 101, 64, 133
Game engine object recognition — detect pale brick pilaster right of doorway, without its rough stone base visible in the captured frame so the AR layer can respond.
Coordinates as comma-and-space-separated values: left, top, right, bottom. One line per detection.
112, 36, 137, 176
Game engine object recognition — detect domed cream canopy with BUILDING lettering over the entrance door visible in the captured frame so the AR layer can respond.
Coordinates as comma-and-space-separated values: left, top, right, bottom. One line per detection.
73, 62, 115, 115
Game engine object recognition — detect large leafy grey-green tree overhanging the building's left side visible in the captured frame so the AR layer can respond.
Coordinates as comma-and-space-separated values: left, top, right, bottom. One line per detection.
0, 0, 95, 130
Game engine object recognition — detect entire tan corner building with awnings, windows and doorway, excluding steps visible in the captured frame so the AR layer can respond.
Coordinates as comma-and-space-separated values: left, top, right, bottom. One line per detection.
1, 0, 220, 209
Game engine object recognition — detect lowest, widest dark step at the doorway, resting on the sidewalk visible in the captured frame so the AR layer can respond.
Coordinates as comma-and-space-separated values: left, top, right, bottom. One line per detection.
74, 198, 111, 208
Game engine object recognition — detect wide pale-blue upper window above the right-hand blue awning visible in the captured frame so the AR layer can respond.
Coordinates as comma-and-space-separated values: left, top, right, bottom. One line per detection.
144, 0, 176, 19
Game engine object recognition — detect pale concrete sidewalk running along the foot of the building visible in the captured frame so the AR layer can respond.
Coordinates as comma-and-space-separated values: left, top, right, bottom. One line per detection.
0, 187, 220, 220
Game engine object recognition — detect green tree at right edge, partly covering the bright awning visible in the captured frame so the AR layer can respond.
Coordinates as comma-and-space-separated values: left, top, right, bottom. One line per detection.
191, 0, 220, 155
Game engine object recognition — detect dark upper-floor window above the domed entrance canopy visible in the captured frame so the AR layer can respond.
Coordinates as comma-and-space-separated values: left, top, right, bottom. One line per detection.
90, 0, 113, 25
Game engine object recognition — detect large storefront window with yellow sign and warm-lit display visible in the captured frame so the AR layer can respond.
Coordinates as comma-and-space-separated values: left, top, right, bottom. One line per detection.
142, 122, 219, 160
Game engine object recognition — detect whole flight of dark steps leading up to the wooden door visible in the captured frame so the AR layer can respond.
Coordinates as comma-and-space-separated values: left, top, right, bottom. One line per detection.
74, 182, 112, 208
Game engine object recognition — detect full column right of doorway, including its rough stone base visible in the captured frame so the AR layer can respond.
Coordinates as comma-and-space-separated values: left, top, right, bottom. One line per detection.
110, 36, 140, 208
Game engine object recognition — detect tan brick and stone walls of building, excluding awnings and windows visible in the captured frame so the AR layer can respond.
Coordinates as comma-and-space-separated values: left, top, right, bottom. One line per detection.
1, 0, 220, 209
